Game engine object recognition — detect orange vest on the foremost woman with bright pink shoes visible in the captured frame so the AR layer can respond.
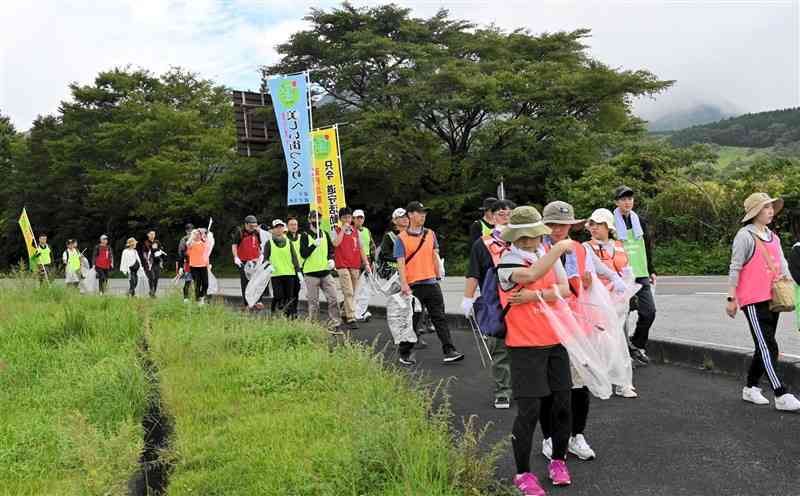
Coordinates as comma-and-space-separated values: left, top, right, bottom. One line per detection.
498, 269, 569, 348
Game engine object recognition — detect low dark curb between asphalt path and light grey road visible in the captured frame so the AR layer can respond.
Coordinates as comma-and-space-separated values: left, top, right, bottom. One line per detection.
223, 295, 800, 391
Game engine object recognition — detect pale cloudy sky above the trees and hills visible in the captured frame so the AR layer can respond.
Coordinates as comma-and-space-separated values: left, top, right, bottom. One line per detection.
0, 0, 800, 130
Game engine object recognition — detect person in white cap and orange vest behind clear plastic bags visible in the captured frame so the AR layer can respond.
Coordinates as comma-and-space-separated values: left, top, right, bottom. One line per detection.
584, 208, 639, 398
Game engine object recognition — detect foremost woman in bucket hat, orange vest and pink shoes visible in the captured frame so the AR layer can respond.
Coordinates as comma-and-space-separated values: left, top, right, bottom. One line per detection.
497, 206, 574, 496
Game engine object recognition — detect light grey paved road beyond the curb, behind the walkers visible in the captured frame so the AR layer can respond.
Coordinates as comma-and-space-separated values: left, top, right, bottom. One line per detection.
94, 276, 800, 361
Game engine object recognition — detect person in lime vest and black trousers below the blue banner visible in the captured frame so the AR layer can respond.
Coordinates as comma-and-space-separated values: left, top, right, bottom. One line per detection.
264, 219, 300, 318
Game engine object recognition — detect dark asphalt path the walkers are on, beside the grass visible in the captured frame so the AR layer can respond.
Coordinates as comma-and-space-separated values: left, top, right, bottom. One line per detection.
352, 319, 800, 496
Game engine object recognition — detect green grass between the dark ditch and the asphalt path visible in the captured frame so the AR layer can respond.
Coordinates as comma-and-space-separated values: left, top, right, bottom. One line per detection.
148, 300, 504, 496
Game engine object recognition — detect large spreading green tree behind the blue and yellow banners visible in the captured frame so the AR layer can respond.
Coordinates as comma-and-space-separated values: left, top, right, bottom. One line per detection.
262, 3, 671, 252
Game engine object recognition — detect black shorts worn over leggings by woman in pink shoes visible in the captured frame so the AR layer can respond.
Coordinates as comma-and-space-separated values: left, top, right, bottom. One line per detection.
508, 344, 572, 399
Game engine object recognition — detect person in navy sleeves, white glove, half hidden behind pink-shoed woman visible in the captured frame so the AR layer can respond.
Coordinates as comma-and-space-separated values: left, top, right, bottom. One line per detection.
461, 200, 516, 409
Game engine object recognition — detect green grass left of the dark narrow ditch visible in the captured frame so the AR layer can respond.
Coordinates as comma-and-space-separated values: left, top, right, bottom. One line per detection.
0, 278, 152, 495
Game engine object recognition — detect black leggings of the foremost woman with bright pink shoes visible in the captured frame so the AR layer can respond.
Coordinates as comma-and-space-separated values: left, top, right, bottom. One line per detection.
511, 391, 570, 474
